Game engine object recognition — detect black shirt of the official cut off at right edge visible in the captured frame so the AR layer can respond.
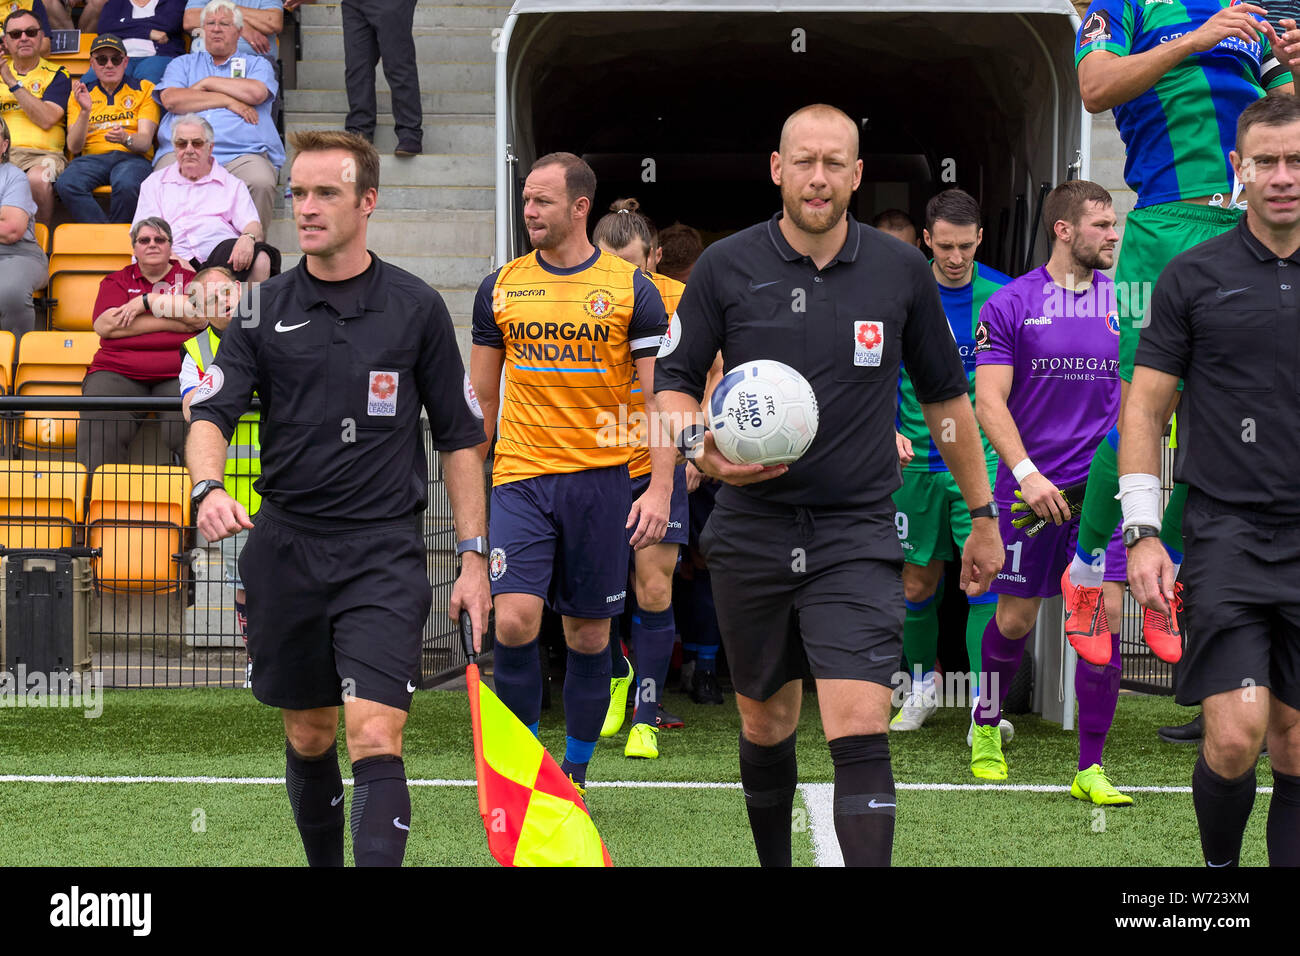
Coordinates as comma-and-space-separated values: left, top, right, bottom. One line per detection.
1135, 216, 1300, 516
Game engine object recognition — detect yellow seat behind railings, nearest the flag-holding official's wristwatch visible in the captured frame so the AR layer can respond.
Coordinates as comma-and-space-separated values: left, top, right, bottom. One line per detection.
86, 464, 190, 593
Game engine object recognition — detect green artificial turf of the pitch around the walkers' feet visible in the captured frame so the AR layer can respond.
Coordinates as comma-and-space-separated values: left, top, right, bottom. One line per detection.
0, 689, 1271, 866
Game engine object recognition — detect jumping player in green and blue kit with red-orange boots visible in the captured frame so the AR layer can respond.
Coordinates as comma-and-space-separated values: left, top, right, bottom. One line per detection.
1063, 0, 1300, 681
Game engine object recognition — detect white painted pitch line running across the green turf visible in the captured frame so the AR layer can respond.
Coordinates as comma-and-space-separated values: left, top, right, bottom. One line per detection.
0, 774, 1273, 796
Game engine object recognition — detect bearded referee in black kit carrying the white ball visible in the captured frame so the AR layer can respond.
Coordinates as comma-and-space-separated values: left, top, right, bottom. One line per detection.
655, 105, 1002, 866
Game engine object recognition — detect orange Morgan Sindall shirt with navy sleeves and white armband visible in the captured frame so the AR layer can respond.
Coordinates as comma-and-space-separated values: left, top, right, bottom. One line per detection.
473, 250, 667, 485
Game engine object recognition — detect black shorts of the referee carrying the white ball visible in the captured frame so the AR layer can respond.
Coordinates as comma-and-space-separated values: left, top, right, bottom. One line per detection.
699, 493, 906, 700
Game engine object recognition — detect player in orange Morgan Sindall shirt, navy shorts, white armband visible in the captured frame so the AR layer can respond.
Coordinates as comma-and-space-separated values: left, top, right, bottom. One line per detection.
469, 152, 676, 787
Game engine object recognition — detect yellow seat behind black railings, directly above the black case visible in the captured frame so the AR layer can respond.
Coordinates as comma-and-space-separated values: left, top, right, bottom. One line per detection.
0, 462, 86, 549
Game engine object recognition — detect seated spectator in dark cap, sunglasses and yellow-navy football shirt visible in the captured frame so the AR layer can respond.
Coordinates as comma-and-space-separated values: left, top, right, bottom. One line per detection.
55, 34, 160, 222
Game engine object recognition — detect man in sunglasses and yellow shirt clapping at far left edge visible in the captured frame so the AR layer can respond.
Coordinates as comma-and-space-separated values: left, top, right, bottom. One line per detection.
0, 10, 72, 225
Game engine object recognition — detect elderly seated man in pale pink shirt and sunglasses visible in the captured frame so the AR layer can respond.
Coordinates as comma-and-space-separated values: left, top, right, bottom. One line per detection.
133, 113, 280, 282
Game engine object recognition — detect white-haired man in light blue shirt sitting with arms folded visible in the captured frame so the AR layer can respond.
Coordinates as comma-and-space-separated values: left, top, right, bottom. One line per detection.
153, 0, 285, 222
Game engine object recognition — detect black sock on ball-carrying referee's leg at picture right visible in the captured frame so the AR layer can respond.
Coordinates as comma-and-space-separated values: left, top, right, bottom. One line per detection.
829, 734, 896, 866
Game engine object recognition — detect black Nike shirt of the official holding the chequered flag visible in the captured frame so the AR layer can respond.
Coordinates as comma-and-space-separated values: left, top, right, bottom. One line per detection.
191, 252, 484, 522
